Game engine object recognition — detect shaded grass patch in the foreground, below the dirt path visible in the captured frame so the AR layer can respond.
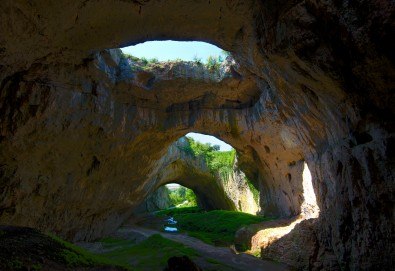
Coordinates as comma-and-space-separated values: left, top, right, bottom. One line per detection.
102, 234, 199, 271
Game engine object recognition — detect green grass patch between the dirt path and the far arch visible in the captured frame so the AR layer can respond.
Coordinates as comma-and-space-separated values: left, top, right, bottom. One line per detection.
157, 207, 270, 246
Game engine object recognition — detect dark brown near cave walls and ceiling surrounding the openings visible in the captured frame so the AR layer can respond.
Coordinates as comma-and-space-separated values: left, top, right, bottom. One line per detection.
0, 0, 395, 270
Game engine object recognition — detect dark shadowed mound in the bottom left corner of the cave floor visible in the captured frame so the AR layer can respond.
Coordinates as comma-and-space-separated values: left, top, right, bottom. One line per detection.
0, 227, 129, 270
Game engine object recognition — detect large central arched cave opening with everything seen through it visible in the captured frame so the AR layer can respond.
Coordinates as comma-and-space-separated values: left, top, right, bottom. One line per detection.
137, 132, 260, 215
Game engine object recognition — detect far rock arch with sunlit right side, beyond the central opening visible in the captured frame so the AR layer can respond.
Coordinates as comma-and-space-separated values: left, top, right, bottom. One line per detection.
134, 137, 259, 214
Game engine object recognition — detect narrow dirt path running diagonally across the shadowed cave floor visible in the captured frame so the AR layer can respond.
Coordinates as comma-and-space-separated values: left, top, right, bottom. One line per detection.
128, 226, 291, 271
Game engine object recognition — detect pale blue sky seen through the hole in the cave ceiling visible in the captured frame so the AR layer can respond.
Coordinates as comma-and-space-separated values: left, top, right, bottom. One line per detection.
121, 40, 222, 62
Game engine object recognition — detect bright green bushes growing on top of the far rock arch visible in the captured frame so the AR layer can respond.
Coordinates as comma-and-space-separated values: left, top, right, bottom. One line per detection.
180, 137, 236, 177
